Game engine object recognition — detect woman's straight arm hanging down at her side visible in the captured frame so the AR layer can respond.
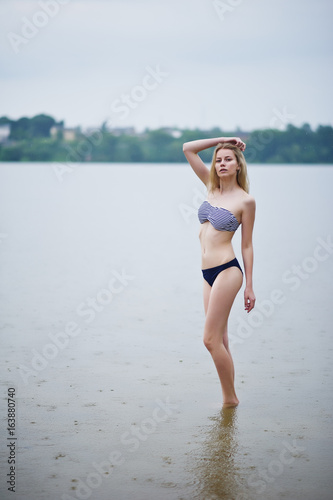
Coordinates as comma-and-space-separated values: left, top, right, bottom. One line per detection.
242, 196, 256, 313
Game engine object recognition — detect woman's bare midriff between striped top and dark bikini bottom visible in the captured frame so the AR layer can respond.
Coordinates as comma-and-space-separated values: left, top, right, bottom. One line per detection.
199, 221, 235, 269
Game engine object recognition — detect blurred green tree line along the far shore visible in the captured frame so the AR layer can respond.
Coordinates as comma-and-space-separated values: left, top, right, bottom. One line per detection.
0, 115, 333, 163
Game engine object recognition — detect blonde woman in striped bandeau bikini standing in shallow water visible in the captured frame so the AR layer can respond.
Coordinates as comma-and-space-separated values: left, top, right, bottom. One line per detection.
183, 137, 255, 406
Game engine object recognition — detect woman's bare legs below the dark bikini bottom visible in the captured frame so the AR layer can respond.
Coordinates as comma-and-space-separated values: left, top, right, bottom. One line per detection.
204, 267, 243, 405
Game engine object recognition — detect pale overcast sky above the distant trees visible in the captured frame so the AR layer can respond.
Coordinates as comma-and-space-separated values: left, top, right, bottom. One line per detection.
0, 0, 333, 131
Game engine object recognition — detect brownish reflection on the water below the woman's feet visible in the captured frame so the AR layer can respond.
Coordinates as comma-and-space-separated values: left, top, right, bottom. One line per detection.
191, 407, 244, 500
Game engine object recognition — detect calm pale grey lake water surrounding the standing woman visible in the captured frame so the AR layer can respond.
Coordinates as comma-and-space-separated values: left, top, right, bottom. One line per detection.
0, 164, 333, 500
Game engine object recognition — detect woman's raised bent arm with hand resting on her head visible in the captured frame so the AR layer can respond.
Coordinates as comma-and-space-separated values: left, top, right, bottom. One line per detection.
183, 137, 245, 186
